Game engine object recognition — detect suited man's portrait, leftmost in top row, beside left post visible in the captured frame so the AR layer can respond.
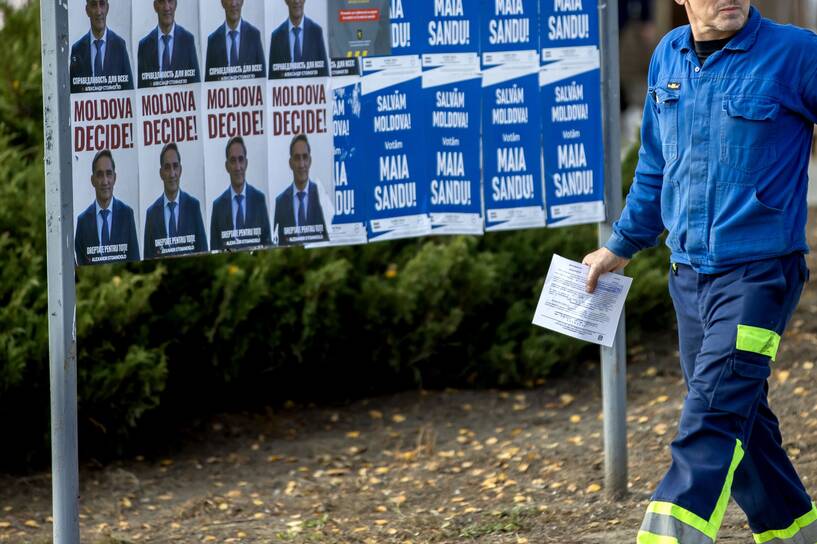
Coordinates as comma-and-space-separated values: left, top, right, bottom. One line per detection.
69, 0, 133, 93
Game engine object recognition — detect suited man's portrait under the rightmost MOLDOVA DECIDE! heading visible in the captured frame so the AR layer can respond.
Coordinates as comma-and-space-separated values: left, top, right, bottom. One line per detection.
273, 134, 329, 246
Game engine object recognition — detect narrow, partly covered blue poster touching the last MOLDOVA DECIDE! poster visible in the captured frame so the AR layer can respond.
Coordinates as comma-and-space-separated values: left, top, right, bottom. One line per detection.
310, 67, 368, 247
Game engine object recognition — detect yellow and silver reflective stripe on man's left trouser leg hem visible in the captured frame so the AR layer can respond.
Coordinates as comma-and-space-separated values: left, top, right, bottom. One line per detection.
637, 440, 743, 544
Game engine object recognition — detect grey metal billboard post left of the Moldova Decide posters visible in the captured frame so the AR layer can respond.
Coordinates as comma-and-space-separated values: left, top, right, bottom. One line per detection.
40, 0, 79, 544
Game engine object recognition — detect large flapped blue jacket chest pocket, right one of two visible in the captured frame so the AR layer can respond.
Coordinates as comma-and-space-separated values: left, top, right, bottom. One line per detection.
721, 96, 780, 174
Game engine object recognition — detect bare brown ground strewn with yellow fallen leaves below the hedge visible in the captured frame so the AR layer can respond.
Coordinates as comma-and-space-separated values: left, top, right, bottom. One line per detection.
0, 218, 817, 544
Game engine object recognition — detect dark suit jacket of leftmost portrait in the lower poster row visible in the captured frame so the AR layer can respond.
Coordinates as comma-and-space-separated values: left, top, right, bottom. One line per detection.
74, 198, 139, 265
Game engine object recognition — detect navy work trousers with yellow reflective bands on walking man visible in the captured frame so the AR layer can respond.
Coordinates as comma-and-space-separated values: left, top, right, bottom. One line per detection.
638, 252, 817, 544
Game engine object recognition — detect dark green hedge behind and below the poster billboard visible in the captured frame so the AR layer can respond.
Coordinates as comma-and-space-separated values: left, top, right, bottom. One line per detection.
0, 0, 671, 467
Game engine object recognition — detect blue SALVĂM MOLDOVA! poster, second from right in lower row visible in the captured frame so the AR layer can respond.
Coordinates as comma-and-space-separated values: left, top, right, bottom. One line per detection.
482, 51, 545, 231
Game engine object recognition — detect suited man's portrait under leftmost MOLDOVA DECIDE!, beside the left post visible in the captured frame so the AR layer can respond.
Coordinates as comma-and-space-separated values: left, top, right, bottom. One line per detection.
74, 149, 139, 265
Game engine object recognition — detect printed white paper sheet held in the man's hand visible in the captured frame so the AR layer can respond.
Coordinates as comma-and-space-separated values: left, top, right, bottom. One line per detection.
533, 255, 633, 347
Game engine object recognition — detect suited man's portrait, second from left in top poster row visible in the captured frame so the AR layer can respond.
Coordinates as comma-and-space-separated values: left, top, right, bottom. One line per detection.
136, 0, 200, 88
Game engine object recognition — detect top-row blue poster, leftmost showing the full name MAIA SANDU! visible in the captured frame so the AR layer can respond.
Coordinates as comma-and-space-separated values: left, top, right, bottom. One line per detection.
417, 0, 480, 53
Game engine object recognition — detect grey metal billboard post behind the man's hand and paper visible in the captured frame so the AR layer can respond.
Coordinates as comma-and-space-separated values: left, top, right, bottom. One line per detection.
599, 0, 627, 498
